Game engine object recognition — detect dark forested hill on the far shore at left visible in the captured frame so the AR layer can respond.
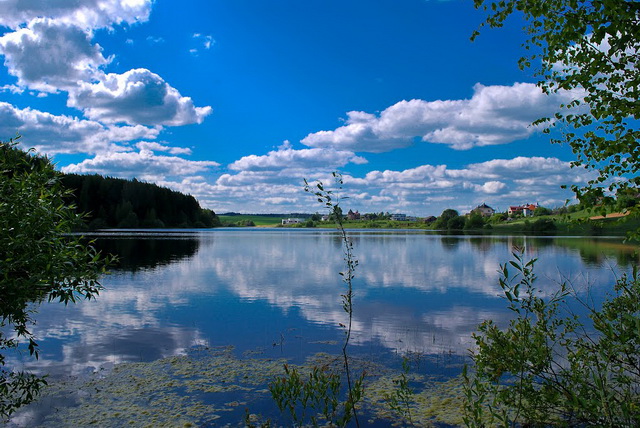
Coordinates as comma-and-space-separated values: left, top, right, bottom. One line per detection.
62, 174, 220, 229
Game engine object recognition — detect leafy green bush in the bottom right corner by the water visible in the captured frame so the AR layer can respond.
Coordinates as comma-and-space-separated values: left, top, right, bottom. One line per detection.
464, 253, 640, 427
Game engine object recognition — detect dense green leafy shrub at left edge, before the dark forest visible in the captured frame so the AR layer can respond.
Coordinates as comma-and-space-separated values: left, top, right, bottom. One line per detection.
0, 140, 109, 420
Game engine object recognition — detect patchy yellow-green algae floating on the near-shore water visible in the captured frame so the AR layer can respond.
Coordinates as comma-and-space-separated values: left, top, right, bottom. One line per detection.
20, 346, 463, 428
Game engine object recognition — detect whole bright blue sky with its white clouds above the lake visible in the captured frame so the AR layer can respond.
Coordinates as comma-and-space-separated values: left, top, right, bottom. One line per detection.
0, 0, 588, 216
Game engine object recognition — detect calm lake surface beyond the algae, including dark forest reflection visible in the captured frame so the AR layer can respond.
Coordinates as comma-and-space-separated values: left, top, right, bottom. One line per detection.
11, 228, 638, 426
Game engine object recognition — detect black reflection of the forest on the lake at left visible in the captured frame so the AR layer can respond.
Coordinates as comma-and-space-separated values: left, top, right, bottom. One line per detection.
94, 237, 200, 272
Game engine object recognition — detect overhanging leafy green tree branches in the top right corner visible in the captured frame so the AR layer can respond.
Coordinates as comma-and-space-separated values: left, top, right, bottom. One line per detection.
472, 0, 640, 206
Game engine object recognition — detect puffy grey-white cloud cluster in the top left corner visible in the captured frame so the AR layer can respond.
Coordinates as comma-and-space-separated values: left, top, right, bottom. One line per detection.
0, 0, 213, 130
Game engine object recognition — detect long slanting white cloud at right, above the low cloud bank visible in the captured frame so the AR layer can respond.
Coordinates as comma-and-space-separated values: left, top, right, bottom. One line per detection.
302, 83, 574, 153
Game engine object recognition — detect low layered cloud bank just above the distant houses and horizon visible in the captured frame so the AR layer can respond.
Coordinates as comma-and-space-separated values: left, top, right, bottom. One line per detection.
162, 152, 589, 216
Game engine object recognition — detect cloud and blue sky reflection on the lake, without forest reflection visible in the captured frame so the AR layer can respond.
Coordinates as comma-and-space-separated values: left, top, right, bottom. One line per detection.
17, 230, 636, 374
